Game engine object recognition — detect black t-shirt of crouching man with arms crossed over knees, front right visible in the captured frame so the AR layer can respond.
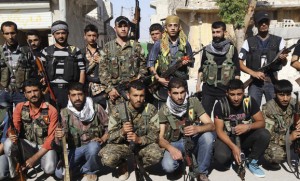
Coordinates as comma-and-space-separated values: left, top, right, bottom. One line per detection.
214, 97, 260, 120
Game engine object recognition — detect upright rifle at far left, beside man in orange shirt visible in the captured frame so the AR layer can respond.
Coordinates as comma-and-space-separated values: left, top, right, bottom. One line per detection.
7, 106, 27, 181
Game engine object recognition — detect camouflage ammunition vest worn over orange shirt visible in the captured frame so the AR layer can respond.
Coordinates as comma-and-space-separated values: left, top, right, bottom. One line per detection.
21, 102, 50, 145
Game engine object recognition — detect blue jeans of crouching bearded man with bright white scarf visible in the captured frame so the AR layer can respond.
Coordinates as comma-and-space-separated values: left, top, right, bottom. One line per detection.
55, 141, 101, 179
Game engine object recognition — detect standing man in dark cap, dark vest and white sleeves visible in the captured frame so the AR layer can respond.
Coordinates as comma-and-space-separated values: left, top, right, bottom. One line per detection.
239, 12, 287, 106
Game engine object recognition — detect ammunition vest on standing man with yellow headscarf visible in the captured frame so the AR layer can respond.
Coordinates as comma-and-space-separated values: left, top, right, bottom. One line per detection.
155, 44, 189, 80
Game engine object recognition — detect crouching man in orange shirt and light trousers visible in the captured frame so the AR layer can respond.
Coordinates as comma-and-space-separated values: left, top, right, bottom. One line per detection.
1, 79, 57, 178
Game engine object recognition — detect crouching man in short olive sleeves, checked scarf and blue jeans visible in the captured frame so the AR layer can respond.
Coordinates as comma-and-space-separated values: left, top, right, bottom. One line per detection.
158, 78, 215, 181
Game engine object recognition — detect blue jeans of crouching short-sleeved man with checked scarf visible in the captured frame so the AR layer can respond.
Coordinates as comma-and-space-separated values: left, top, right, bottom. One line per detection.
162, 132, 215, 174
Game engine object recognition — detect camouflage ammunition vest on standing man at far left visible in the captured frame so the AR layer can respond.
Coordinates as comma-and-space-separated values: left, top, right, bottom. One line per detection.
0, 46, 35, 89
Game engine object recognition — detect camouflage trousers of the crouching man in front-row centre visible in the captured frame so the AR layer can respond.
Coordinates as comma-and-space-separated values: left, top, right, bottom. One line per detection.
99, 143, 162, 168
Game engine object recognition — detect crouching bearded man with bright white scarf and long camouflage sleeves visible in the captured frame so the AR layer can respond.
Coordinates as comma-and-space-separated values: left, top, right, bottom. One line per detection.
55, 83, 108, 181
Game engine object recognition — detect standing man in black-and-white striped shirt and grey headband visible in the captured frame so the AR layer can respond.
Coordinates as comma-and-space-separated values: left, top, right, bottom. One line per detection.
41, 20, 85, 108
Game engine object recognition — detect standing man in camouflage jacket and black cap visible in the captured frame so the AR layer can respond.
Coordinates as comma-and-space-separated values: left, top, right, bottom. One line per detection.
99, 16, 147, 110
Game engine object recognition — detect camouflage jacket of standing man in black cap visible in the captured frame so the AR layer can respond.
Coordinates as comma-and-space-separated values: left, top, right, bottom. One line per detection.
99, 40, 147, 93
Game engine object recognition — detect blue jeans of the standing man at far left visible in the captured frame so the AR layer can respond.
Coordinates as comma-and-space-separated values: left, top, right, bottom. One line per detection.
0, 90, 26, 107
